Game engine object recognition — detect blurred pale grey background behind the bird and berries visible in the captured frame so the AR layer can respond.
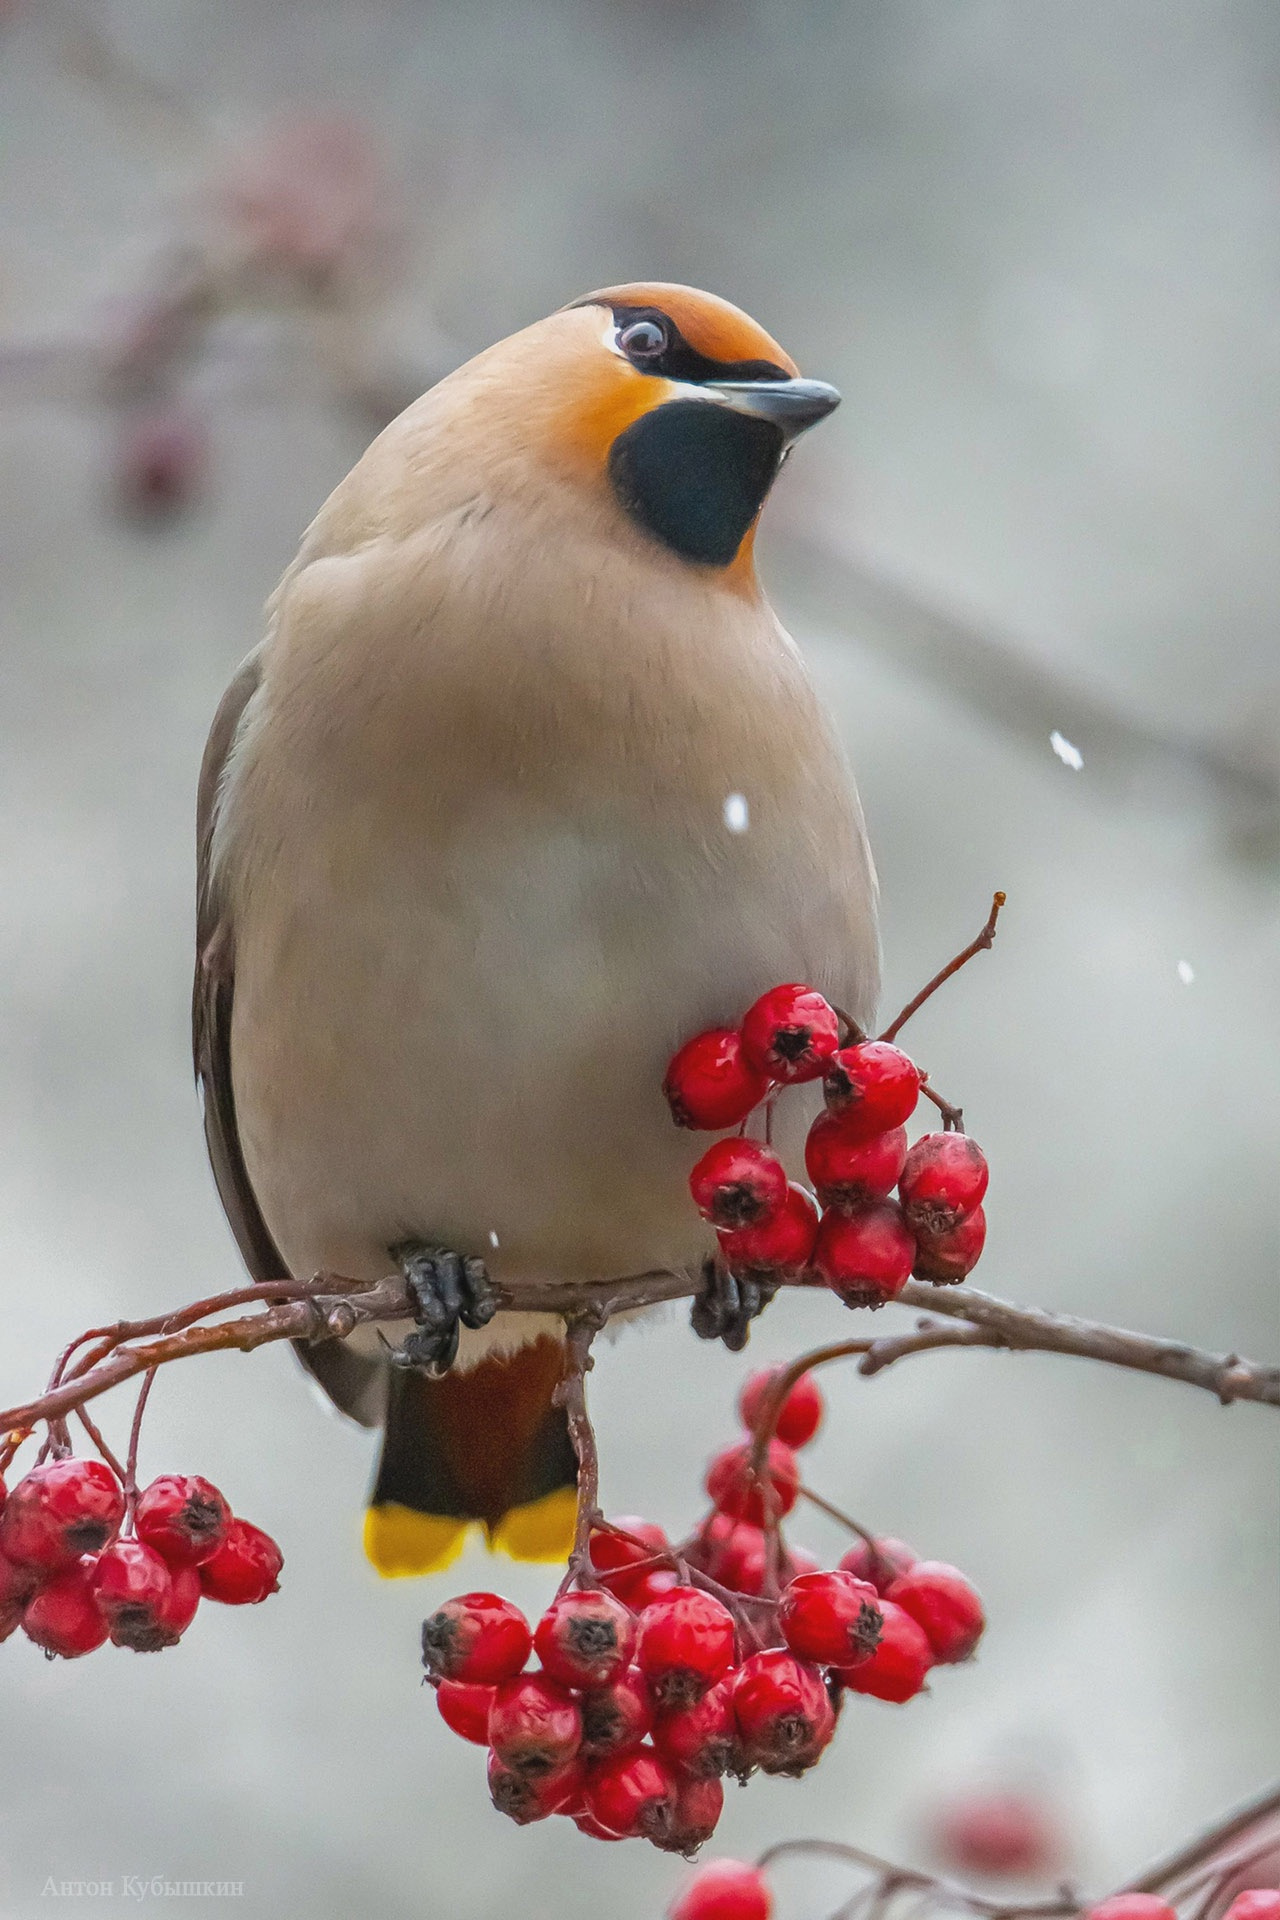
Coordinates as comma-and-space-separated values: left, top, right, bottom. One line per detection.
0, 0, 1280, 1920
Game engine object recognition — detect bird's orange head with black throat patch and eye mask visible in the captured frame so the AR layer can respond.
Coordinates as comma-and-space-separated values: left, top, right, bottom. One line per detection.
441, 284, 841, 572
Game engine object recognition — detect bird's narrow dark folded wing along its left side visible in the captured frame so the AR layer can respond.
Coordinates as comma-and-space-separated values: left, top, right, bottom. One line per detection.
192, 647, 386, 1427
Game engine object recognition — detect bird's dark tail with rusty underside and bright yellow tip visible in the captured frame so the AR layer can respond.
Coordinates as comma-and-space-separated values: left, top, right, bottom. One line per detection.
365, 1338, 578, 1578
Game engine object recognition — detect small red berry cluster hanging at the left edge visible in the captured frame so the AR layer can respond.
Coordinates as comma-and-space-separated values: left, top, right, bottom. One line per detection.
0, 1457, 284, 1661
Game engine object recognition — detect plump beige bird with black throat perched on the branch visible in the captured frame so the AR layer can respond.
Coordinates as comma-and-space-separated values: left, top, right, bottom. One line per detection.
192, 282, 879, 1576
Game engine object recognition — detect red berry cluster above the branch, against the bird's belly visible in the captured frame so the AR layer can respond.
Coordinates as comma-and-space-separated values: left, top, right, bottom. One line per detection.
664, 985, 986, 1308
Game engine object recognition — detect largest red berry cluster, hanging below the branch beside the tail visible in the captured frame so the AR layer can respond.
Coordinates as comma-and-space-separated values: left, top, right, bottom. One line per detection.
422, 1373, 983, 1853
